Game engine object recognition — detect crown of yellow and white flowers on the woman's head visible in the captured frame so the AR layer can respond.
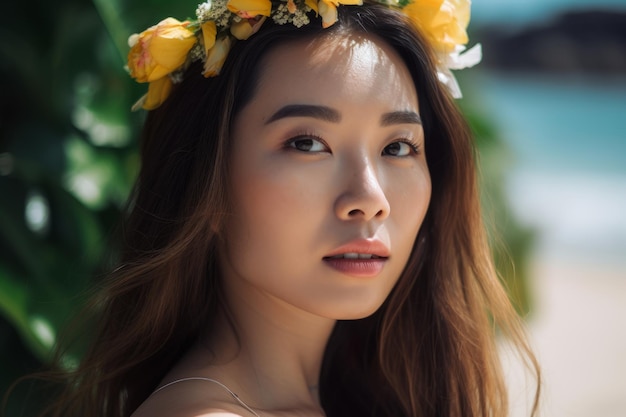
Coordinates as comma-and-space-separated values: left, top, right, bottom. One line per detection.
128, 0, 482, 110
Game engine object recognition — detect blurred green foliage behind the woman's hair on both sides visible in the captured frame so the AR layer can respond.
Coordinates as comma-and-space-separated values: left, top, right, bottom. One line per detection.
0, 0, 530, 415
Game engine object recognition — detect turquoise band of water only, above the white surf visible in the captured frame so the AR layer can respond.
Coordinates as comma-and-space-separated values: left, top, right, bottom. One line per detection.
476, 74, 626, 175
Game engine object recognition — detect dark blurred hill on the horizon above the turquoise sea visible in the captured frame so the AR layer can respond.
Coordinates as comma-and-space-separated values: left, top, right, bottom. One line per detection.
472, 11, 626, 76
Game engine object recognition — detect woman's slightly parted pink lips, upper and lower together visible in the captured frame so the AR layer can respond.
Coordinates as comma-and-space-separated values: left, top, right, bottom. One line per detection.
323, 239, 390, 278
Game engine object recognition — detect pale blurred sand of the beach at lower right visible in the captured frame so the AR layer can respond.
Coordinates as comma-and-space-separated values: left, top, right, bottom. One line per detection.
508, 257, 626, 417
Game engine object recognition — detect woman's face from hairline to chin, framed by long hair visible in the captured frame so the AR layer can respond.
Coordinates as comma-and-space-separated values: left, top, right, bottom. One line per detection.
221, 35, 431, 319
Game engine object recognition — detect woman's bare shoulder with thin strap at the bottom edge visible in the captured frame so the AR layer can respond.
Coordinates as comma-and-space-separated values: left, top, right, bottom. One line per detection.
132, 381, 253, 417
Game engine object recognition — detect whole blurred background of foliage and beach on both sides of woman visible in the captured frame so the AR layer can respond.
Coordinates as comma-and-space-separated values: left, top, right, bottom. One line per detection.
0, 0, 626, 417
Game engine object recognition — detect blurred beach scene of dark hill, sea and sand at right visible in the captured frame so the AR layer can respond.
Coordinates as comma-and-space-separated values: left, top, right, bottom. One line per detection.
464, 0, 626, 417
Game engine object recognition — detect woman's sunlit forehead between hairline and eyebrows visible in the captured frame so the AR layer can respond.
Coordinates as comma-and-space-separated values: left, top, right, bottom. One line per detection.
250, 34, 418, 111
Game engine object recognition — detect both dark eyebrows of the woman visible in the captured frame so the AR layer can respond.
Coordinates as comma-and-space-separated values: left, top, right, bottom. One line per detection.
265, 104, 422, 126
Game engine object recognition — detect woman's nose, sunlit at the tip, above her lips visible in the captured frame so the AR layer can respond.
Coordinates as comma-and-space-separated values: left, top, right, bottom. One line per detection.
335, 159, 391, 221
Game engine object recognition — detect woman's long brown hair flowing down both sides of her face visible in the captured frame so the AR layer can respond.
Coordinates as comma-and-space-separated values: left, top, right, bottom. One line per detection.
28, 4, 538, 417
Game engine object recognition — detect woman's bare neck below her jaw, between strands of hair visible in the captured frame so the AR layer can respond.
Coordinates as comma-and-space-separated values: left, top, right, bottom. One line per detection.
200, 274, 335, 410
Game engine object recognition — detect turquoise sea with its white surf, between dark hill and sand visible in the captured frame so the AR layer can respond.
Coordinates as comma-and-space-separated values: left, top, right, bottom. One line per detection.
472, 74, 626, 263
